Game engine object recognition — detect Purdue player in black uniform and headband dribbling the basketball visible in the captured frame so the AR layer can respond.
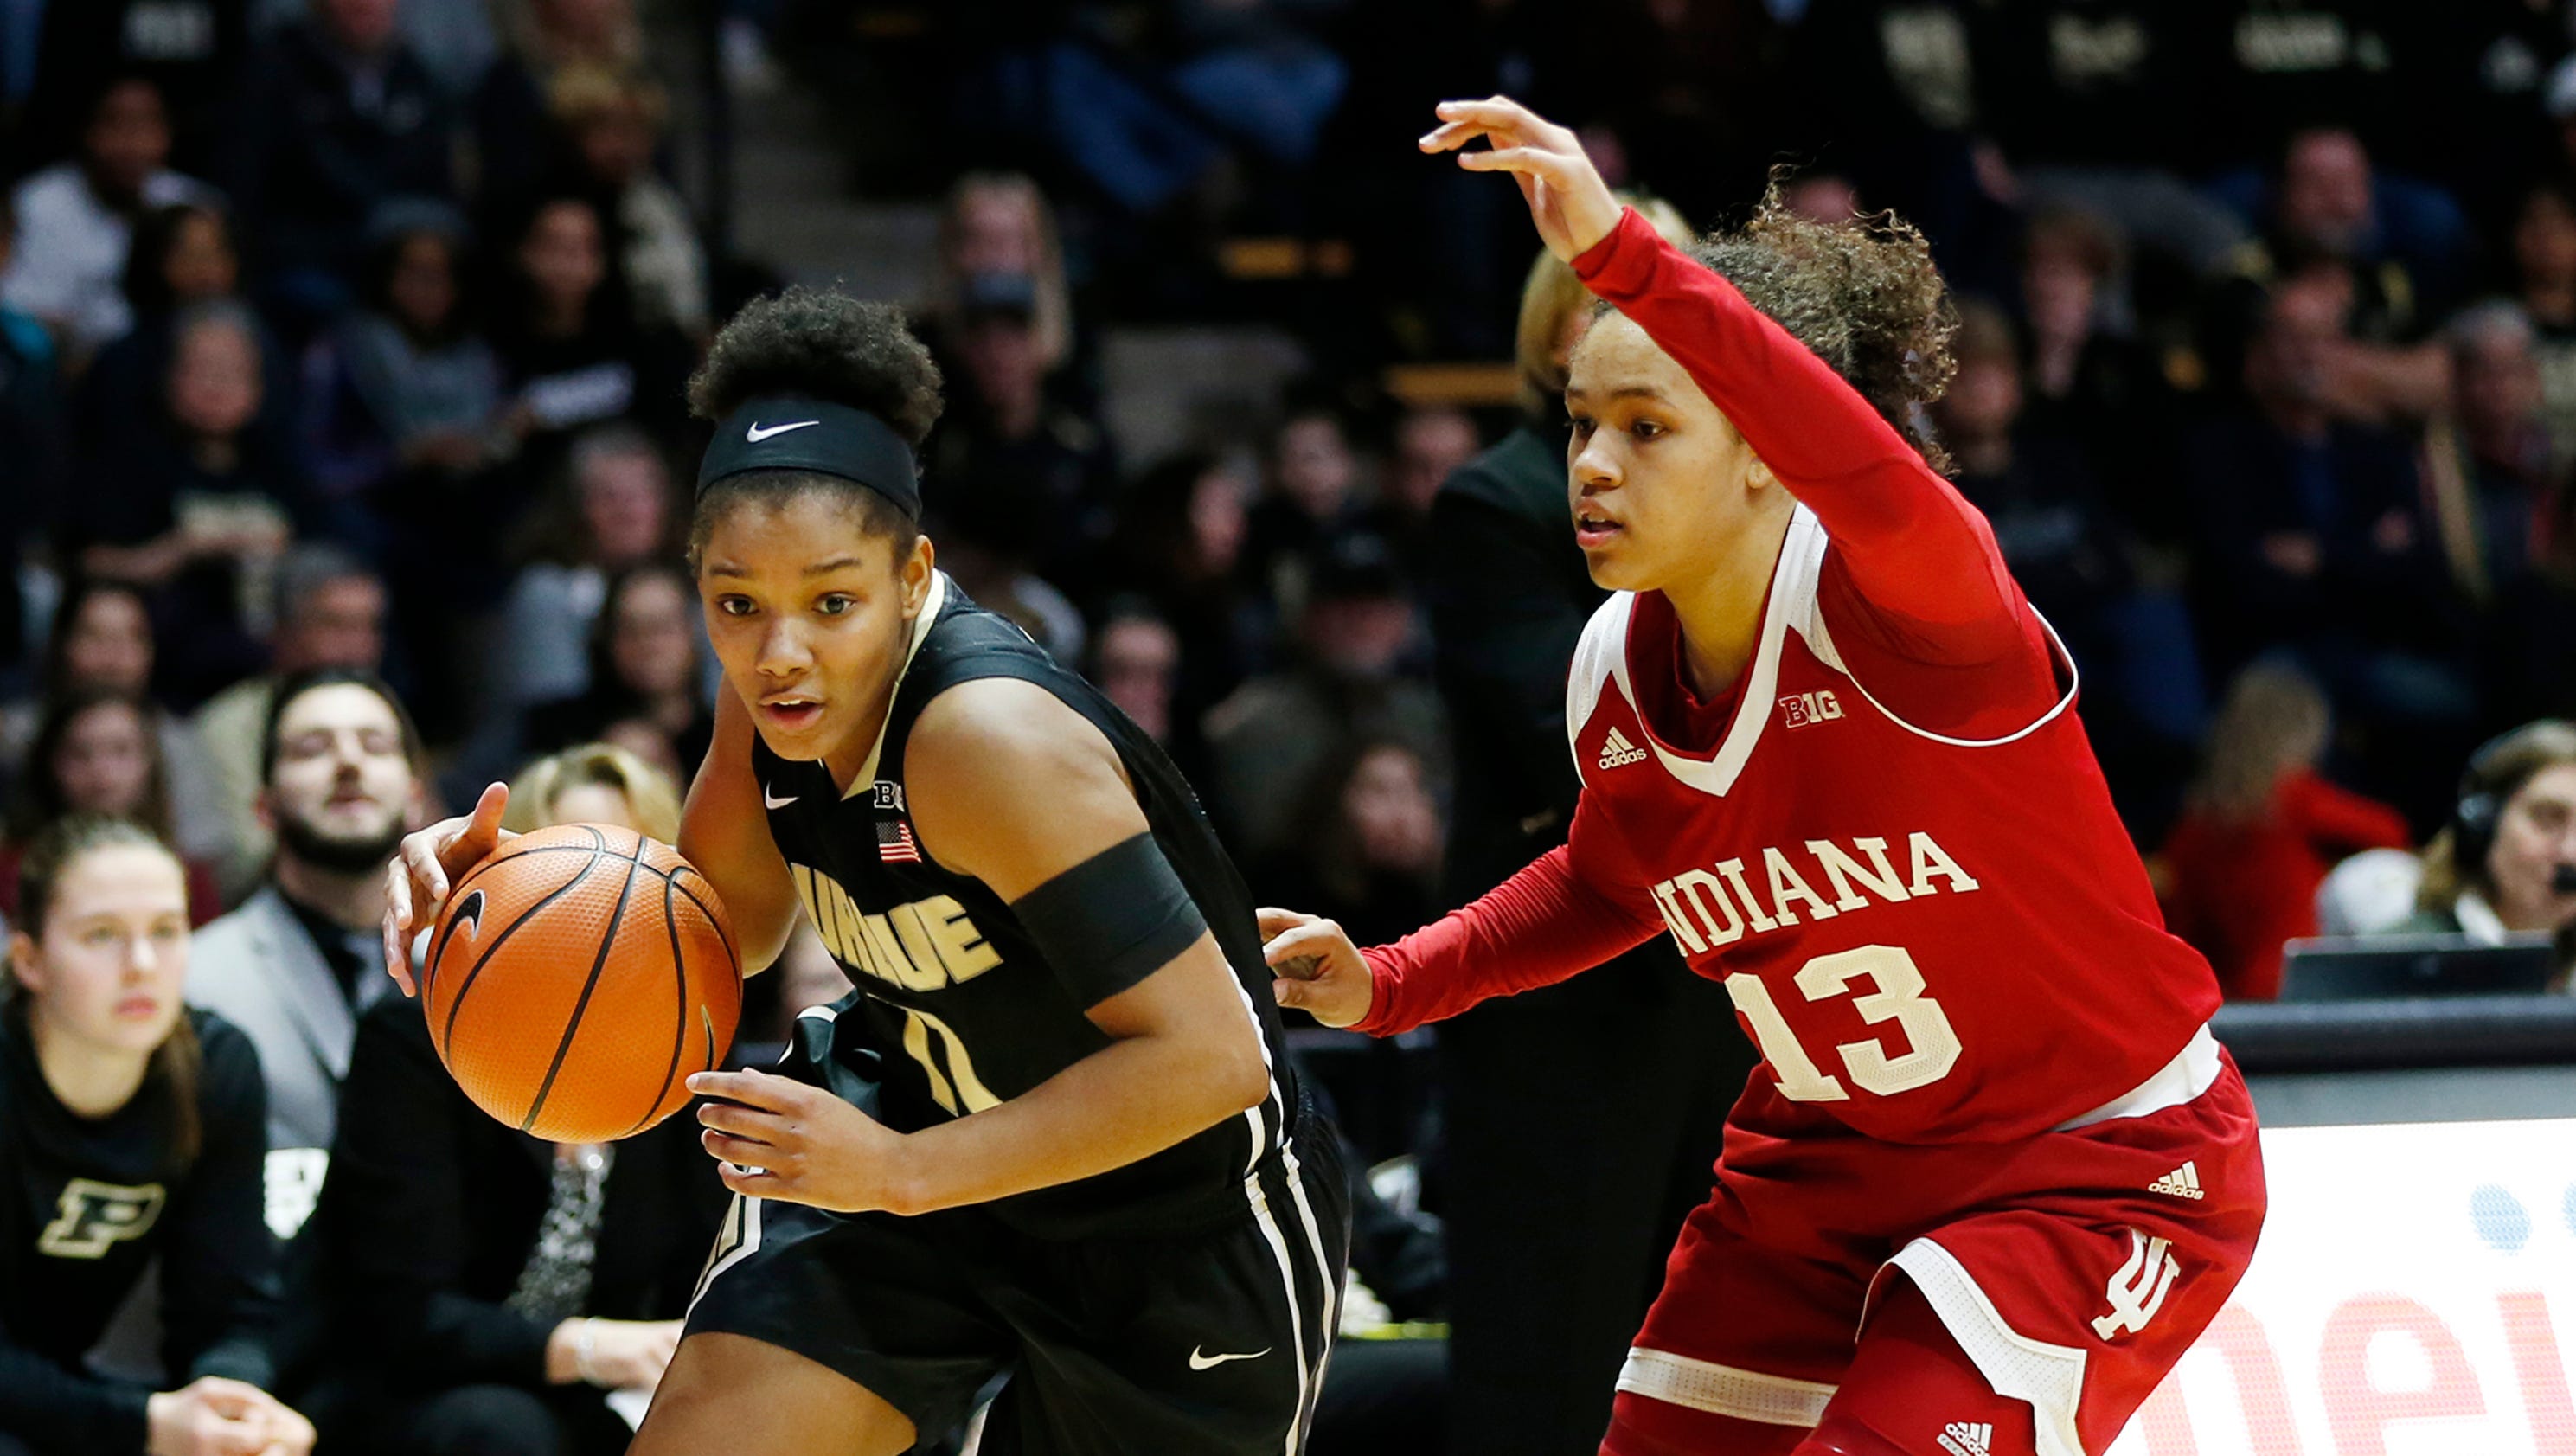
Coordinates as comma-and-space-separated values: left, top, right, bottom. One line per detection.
387, 292, 1347, 1456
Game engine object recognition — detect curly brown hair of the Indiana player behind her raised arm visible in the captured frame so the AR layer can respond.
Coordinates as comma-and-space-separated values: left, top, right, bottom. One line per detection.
1618, 173, 1958, 474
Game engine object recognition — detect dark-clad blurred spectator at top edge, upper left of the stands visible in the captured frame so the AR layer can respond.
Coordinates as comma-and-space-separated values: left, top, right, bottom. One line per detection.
232, 0, 453, 337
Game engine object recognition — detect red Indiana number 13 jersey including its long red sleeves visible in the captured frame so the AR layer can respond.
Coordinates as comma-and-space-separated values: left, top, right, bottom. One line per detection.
1362, 214, 2218, 1142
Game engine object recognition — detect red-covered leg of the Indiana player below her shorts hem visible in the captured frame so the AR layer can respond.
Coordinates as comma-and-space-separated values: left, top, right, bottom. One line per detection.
1796, 1275, 2038, 1456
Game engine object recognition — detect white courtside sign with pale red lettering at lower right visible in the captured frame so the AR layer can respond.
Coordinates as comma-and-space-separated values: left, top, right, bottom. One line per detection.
2110, 1121, 2576, 1456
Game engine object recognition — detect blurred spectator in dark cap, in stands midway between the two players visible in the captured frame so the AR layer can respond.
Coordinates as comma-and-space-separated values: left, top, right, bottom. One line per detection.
1206, 534, 1448, 861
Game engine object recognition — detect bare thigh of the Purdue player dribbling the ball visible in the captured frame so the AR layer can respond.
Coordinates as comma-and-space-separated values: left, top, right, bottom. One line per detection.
626, 1332, 914, 1456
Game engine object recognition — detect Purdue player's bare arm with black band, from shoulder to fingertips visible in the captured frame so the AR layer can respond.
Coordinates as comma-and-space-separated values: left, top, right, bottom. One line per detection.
690, 677, 1270, 1214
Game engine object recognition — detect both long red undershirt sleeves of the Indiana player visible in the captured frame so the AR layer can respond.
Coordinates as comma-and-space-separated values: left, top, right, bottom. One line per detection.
1360, 211, 2058, 1036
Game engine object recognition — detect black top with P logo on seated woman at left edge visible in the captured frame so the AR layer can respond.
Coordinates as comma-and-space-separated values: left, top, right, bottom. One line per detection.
0, 1008, 279, 1451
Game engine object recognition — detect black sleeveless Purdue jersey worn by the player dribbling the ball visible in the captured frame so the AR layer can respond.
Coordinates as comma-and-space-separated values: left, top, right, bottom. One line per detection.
753, 574, 1298, 1237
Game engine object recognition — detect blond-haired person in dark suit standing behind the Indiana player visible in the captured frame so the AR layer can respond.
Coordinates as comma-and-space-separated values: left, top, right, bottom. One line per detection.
1430, 208, 1754, 1456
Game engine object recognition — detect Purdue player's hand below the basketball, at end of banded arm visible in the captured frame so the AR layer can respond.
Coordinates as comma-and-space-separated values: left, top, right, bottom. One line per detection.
688, 1072, 912, 1214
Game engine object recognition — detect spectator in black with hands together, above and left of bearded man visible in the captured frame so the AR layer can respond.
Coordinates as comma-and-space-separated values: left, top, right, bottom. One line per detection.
64, 304, 304, 703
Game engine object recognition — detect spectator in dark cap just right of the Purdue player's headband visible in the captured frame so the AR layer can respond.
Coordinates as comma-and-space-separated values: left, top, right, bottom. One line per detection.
927, 273, 1115, 577
